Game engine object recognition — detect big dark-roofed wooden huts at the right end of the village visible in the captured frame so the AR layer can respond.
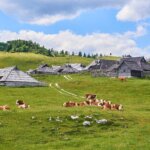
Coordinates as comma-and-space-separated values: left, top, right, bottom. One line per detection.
90, 57, 150, 78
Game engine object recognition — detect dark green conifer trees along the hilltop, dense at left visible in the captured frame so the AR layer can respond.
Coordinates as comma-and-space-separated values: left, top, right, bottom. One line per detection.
0, 40, 102, 58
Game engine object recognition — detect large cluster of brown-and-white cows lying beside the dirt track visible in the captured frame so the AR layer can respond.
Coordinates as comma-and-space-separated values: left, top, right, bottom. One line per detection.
63, 94, 123, 110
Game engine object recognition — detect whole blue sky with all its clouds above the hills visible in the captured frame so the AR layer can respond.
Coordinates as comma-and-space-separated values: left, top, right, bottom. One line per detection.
0, 0, 150, 57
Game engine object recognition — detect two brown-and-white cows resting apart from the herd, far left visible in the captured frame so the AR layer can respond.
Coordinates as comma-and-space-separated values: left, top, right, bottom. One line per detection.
0, 100, 30, 111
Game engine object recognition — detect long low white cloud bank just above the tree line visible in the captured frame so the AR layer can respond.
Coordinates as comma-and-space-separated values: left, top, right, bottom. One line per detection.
0, 27, 150, 56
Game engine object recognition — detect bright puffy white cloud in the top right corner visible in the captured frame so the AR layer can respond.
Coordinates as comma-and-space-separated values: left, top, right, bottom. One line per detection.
117, 0, 150, 21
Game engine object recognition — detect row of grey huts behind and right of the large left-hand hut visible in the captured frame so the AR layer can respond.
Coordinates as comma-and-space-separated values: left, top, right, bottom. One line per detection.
28, 56, 150, 78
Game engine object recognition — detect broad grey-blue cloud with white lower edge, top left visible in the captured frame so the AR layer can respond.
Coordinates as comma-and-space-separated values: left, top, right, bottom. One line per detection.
0, 0, 128, 25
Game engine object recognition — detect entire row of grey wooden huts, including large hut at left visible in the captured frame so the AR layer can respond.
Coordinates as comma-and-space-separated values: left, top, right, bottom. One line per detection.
0, 57, 150, 86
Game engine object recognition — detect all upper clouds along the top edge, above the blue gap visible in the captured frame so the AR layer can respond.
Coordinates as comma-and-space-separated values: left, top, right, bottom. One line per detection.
0, 0, 150, 25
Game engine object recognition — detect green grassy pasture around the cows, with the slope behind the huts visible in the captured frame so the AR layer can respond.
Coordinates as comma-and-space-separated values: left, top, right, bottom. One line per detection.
0, 53, 150, 150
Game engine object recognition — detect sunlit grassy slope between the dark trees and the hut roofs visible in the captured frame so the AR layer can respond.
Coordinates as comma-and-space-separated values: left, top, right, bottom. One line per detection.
0, 52, 93, 71
